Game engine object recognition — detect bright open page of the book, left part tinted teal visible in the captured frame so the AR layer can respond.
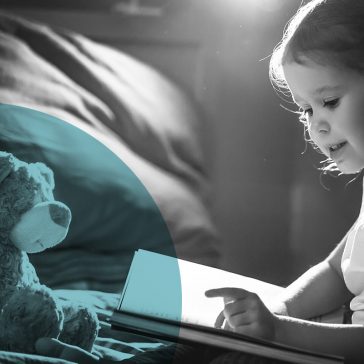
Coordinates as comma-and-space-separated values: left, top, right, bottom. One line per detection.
120, 250, 282, 327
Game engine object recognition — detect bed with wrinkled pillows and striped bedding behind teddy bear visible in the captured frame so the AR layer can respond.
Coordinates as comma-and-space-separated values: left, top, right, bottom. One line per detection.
0, 12, 220, 363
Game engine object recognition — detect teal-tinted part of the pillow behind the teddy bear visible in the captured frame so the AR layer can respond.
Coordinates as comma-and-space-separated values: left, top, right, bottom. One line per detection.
0, 105, 176, 251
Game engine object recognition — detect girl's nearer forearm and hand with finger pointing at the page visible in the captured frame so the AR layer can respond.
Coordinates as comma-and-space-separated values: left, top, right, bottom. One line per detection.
206, 287, 364, 364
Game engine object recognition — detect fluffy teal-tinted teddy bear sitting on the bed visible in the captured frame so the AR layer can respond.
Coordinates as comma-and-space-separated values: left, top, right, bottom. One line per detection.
0, 151, 99, 353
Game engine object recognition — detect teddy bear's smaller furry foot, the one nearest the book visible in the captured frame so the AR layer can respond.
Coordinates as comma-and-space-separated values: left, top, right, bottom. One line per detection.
59, 302, 99, 352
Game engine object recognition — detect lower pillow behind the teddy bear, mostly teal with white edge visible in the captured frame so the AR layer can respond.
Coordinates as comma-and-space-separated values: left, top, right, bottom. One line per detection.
0, 104, 218, 292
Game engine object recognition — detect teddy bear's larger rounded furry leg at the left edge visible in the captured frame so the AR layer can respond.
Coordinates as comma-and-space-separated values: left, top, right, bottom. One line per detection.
0, 285, 63, 353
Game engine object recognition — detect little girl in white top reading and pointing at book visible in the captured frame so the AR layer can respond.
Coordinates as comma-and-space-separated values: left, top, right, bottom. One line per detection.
206, 0, 364, 363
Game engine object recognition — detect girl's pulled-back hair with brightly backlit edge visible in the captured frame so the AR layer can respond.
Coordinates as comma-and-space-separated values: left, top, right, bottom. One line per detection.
269, 0, 364, 90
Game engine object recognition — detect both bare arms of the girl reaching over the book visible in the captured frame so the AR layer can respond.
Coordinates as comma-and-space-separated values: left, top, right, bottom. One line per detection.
206, 226, 364, 363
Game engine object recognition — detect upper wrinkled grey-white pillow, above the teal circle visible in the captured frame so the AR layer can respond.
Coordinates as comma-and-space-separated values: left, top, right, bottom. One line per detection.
0, 12, 204, 190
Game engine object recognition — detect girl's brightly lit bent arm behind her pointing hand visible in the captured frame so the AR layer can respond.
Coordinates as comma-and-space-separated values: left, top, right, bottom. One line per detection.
270, 230, 352, 319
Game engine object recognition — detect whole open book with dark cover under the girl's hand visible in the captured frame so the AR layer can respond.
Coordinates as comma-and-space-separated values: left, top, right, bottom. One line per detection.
111, 250, 344, 364
